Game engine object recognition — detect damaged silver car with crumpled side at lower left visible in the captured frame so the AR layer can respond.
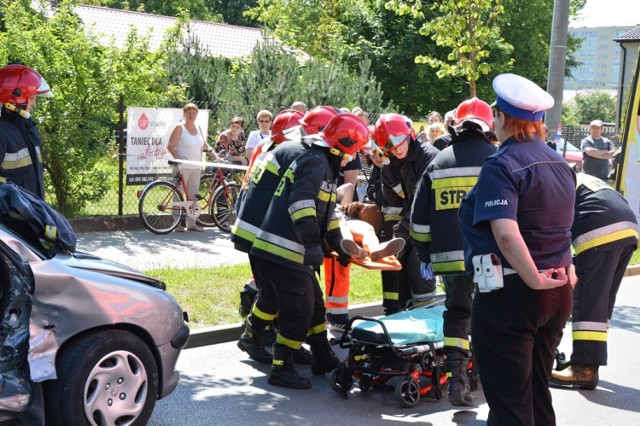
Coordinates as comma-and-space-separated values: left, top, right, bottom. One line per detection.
0, 208, 189, 425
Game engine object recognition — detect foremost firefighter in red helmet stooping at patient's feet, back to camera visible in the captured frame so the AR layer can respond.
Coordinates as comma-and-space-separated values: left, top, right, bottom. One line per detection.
251, 114, 369, 389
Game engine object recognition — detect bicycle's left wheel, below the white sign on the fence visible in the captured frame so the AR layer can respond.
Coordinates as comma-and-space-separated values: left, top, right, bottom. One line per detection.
138, 181, 186, 234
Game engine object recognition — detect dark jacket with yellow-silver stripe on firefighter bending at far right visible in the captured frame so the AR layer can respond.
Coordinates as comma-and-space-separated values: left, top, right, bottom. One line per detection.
571, 173, 638, 255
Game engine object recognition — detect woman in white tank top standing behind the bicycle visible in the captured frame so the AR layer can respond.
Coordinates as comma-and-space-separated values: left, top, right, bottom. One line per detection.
168, 103, 211, 232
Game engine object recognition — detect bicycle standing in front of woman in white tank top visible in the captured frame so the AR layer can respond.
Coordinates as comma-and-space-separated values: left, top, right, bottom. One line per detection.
138, 160, 240, 235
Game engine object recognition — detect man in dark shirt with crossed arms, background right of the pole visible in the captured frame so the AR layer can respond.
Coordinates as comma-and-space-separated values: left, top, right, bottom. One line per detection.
580, 120, 618, 182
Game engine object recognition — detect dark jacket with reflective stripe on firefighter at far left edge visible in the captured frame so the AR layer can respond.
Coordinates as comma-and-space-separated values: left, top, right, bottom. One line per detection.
0, 109, 44, 199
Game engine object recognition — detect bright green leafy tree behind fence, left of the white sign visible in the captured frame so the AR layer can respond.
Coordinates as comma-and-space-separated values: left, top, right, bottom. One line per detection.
0, 1, 181, 214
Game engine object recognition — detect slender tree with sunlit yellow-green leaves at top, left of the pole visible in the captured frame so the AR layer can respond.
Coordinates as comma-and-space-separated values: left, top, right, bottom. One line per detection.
387, 0, 513, 96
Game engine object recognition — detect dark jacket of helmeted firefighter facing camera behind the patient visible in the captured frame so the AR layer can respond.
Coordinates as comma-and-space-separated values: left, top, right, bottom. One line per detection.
382, 139, 440, 240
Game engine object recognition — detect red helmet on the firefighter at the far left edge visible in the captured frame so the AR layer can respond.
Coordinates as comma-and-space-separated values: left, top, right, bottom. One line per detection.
0, 64, 53, 105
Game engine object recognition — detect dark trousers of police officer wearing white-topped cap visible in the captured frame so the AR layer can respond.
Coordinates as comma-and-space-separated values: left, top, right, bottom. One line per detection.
471, 275, 572, 426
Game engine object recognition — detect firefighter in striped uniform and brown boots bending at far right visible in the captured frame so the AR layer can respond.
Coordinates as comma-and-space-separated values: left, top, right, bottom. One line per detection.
550, 173, 638, 389
